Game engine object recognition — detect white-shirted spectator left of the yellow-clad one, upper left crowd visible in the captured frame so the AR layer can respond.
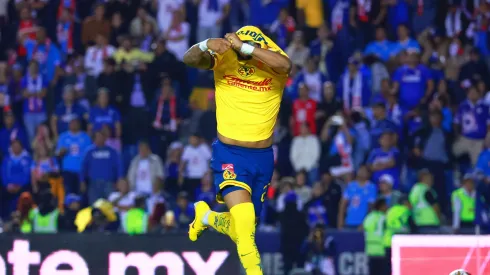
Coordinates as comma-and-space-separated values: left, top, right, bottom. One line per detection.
84, 33, 116, 78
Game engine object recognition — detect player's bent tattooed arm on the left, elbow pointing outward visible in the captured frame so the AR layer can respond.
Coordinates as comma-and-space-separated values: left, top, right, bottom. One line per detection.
184, 38, 231, 70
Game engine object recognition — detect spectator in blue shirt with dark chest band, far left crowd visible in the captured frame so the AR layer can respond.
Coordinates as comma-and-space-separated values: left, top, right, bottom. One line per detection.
22, 61, 48, 141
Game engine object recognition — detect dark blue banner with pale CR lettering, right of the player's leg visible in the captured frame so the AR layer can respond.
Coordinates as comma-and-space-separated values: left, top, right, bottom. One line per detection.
256, 231, 369, 275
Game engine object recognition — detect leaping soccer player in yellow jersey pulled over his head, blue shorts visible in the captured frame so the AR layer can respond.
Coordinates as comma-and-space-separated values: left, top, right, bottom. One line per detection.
184, 26, 291, 275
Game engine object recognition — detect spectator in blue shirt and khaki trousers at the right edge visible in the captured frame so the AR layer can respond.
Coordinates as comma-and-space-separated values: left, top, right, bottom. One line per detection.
453, 86, 490, 165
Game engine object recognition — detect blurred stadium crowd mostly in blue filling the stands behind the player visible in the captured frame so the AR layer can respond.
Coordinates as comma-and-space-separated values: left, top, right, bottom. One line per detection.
0, 0, 490, 274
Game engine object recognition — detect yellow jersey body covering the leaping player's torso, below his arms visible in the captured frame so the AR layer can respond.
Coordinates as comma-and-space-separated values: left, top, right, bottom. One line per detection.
212, 50, 288, 142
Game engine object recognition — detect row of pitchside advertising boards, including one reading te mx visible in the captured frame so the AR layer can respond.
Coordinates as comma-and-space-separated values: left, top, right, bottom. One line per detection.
0, 231, 484, 275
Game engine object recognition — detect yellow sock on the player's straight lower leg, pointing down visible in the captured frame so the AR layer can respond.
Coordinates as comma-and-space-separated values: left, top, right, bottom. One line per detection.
230, 202, 263, 275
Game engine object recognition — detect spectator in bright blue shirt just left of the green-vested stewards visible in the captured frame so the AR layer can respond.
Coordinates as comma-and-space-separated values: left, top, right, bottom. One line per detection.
337, 166, 377, 230
